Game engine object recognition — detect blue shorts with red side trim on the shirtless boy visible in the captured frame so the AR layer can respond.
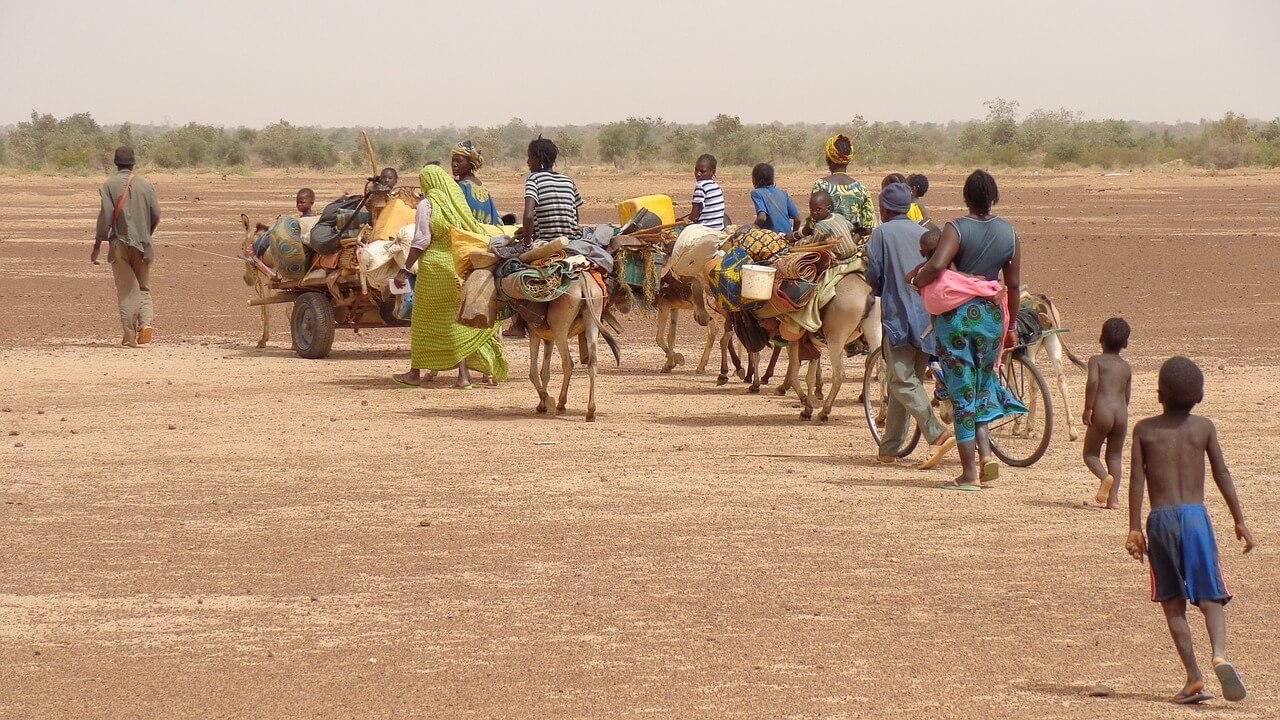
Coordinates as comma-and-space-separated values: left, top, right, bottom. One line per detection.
1147, 505, 1231, 606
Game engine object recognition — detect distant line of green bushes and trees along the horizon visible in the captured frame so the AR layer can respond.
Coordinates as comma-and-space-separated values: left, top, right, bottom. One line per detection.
0, 99, 1280, 172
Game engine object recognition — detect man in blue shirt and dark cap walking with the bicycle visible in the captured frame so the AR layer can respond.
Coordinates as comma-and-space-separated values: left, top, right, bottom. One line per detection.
867, 182, 956, 469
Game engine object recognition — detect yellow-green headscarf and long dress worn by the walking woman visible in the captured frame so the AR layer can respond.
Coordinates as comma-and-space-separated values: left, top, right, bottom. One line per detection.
412, 165, 507, 380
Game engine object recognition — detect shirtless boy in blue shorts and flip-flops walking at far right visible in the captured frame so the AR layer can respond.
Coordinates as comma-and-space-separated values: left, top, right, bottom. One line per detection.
1125, 357, 1253, 705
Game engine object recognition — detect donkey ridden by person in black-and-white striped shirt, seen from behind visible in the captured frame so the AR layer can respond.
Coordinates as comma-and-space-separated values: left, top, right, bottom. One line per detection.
517, 275, 622, 423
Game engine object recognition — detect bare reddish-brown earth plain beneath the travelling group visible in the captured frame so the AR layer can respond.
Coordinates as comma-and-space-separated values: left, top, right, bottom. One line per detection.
0, 169, 1280, 719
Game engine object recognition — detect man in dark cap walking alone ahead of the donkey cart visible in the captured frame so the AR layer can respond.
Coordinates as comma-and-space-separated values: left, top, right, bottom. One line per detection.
88, 146, 160, 347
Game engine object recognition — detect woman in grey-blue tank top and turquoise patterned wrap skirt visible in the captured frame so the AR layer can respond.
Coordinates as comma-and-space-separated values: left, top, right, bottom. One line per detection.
915, 170, 1027, 491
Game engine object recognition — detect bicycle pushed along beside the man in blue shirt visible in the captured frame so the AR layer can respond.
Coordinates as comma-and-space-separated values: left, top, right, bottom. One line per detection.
863, 345, 1053, 468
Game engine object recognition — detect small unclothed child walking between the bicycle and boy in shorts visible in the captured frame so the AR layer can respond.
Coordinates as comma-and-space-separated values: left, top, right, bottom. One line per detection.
1084, 318, 1133, 509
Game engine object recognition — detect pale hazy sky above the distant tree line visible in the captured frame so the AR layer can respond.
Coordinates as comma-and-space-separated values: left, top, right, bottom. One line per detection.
0, 0, 1280, 127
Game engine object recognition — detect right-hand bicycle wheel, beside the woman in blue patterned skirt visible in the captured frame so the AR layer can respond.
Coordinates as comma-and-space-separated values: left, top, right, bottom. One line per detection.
987, 352, 1053, 468
